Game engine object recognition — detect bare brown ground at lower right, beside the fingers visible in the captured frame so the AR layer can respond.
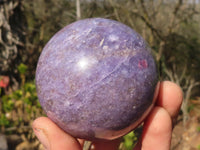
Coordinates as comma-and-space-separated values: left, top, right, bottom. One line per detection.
171, 101, 200, 150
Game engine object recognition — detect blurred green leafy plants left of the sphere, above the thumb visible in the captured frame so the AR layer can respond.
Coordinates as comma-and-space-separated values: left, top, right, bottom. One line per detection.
0, 80, 43, 131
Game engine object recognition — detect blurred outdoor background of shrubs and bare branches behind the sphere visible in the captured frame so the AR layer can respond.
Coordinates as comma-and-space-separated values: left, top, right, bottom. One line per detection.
0, 0, 200, 150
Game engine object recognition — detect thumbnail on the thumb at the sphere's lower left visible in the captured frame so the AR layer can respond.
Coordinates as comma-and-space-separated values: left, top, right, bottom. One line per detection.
33, 128, 50, 150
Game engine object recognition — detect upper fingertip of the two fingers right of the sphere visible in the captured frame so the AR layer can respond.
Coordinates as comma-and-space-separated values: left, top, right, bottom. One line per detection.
156, 81, 183, 118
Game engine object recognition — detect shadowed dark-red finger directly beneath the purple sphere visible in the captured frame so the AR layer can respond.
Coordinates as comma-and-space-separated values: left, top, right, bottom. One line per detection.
92, 138, 121, 150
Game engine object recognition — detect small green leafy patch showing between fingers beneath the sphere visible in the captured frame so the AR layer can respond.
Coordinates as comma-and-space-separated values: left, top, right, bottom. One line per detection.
123, 131, 137, 150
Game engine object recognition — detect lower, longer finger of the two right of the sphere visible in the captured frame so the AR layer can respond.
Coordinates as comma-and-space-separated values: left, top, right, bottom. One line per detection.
134, 107, 172, 150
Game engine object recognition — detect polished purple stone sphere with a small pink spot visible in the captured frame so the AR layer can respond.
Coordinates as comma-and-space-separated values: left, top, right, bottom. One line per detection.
36, 18, 158, 140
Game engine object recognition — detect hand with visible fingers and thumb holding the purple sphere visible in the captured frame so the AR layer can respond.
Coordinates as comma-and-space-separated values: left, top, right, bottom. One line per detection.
32, 81, 183, 150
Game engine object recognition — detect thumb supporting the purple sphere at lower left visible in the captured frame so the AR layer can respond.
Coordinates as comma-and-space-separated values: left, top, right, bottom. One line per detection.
32, 117, 81, 150
